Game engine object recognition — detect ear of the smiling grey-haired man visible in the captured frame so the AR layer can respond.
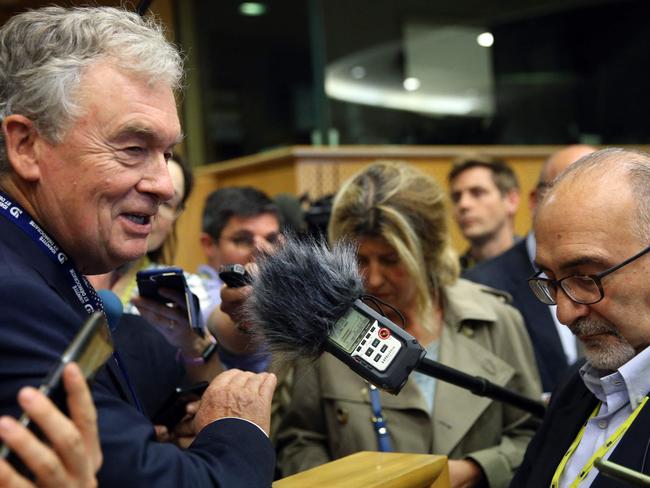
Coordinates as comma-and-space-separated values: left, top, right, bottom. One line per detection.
2, 114, 41, 181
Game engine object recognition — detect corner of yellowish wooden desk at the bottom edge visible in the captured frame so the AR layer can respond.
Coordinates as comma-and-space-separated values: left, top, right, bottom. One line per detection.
273, 451, 449, 488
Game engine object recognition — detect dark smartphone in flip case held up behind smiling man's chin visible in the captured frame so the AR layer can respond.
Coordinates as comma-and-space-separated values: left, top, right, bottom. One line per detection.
135, 267, 205, 337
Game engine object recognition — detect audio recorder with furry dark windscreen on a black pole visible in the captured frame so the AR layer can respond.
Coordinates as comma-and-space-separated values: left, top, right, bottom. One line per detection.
243, 237, 546, 417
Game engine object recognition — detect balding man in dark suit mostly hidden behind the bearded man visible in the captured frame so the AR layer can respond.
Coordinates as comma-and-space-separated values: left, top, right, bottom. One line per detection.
463, 145, 596, 392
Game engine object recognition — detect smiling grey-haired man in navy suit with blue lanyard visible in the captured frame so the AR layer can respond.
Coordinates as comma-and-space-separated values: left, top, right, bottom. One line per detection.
0, 7, 275, 488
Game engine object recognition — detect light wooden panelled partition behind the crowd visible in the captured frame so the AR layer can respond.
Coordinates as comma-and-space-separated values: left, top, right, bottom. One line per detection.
171, 146, 648, 271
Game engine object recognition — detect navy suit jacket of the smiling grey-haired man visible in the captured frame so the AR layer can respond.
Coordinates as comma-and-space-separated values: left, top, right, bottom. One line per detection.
0, 212, 275, 488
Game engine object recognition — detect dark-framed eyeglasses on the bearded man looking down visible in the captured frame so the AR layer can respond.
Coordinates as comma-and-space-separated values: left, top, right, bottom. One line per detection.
528, 246, 650, 305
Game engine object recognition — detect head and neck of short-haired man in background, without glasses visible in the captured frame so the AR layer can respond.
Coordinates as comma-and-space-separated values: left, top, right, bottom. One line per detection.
448, 158, 519, 270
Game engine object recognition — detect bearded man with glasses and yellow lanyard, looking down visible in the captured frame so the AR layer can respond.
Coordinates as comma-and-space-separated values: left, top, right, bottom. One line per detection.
512, 149, 650, 487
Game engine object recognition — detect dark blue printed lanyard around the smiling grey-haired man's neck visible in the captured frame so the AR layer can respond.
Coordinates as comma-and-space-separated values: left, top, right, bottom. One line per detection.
0, 191, 143, 413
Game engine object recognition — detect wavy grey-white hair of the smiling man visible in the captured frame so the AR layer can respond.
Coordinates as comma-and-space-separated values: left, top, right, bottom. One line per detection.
0, 7, 183, 174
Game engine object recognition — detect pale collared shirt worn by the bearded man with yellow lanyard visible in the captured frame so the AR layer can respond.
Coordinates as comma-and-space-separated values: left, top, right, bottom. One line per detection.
560, 347, 650, 488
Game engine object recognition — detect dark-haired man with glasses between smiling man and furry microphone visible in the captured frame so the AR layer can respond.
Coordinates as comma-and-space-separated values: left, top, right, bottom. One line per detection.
198, 186, 281, 372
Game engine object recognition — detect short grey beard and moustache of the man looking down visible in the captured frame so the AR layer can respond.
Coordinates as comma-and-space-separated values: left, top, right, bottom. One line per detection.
570, 318, 636, 371
